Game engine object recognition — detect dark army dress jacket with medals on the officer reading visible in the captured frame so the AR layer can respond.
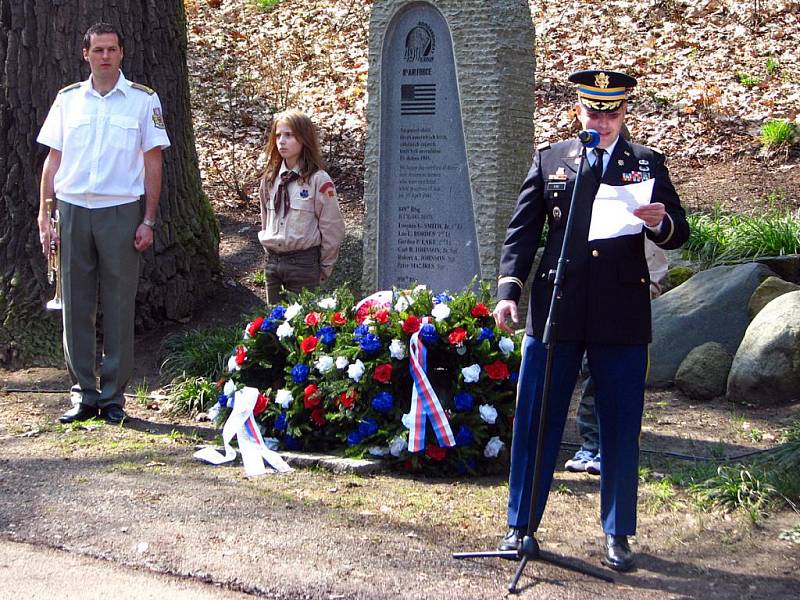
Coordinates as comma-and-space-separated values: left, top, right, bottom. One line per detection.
497, 138, 689, 344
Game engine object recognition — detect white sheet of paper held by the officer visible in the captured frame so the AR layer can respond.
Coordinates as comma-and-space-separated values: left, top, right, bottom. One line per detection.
589, 179, 656, 242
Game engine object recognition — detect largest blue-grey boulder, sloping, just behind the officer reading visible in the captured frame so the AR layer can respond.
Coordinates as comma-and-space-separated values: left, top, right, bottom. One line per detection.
647, 263, 774, 386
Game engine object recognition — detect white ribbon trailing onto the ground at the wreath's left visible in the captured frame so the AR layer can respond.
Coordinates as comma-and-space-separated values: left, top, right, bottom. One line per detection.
194, 387, 292, 477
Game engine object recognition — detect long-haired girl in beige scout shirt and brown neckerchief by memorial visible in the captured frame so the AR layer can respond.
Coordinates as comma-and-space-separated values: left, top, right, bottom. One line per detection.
258, 110, 344, 304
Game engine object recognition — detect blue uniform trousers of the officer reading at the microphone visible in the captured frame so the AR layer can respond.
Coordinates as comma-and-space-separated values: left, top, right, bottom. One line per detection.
508, 335, 647, 535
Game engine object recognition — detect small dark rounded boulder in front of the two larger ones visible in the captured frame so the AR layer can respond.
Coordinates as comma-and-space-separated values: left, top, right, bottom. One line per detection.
675, 342, 733, 401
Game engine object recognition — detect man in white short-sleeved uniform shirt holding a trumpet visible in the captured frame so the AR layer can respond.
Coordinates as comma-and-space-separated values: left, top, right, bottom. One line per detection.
37, 23, 170, 423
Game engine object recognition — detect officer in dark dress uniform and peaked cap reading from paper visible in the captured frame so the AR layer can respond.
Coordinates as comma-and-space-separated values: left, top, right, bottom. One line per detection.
494, 70, 689, 571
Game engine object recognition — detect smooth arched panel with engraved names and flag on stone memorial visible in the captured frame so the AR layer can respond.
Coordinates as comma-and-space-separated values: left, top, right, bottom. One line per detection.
378, 2, 480, 290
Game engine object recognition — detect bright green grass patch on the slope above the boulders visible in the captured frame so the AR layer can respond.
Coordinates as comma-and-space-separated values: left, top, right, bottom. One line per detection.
684, 199, 800, 267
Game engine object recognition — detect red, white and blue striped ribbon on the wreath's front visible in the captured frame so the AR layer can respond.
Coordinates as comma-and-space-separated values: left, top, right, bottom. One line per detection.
408, 317, 456, 452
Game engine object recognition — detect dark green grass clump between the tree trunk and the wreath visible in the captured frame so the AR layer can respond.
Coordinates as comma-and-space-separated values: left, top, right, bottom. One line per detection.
161, 326, 244, 381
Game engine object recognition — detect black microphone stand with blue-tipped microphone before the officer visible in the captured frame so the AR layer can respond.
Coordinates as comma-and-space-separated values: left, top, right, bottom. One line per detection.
453, 135, 614, 594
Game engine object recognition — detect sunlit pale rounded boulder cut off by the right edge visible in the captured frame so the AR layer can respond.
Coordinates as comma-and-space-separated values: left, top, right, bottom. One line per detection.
728, 291, 800, 405
